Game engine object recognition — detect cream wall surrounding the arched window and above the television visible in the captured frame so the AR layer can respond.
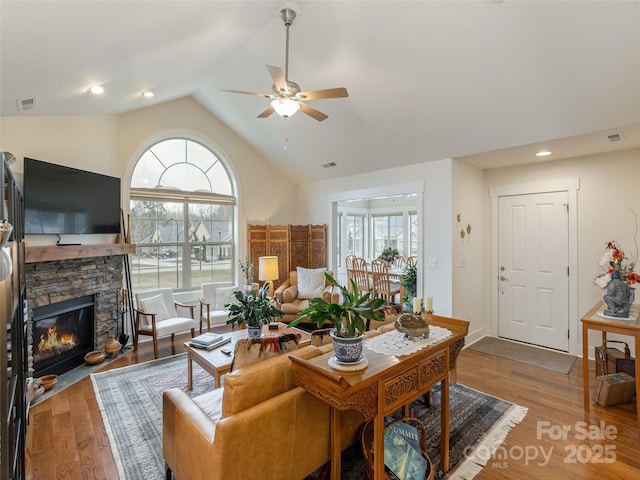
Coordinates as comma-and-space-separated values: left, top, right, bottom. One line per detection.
0, 97, 296, 258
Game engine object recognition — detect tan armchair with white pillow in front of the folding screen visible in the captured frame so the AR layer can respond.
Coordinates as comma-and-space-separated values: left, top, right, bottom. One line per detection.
274, 267, 340, 323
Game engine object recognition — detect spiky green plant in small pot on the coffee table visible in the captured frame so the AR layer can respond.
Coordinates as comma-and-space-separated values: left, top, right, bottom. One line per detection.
225, 283, 284, 338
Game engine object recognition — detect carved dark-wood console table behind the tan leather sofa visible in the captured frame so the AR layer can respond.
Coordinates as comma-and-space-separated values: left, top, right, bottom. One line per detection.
290, 315, 469, 480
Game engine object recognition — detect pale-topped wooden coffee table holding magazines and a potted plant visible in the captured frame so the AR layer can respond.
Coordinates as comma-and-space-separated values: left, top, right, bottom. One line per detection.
184, 322, 311, 390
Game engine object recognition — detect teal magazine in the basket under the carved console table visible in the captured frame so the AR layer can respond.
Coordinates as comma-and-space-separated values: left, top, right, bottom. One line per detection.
384, 428, 428, 480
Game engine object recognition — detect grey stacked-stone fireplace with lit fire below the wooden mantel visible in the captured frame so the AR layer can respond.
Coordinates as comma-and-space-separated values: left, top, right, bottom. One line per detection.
26, 247, 128, 375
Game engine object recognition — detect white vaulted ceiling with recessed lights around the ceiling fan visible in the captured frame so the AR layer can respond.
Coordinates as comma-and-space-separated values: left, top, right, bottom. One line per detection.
0, 0, 640, 182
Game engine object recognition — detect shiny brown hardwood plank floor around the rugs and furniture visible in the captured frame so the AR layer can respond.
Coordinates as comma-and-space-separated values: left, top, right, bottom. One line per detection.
27, 337, 640, 480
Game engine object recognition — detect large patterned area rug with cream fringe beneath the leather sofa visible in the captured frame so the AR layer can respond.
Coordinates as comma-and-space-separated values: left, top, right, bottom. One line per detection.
91, 354, 527, 480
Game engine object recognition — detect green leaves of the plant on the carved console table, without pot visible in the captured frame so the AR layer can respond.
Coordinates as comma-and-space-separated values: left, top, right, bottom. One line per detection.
289, 272, 384, 337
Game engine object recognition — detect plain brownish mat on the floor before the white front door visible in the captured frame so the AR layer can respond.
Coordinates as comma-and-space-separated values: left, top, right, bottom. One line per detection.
467, 337, 577, 374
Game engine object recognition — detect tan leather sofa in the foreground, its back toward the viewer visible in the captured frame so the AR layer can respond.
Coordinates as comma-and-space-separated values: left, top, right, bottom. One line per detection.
162, 345, 362, 480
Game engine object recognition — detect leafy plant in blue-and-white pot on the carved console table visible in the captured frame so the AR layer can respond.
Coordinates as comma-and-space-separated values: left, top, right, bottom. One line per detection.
289, 273, 384, 363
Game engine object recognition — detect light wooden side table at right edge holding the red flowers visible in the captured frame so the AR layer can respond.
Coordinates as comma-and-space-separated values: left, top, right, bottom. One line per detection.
582, 300, 640, 426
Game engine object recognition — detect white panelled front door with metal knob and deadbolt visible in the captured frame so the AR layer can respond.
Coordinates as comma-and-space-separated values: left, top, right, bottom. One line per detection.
498, 192, 569, 352
